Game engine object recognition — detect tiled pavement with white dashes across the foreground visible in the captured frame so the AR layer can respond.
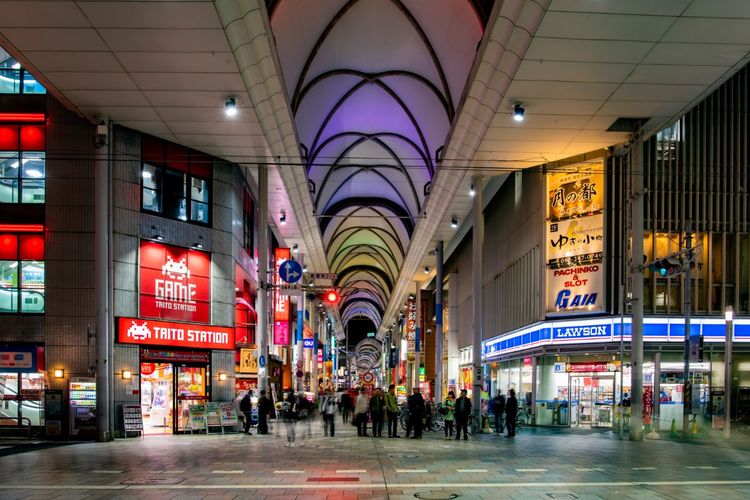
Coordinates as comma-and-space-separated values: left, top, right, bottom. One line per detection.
0, 424, 750, 499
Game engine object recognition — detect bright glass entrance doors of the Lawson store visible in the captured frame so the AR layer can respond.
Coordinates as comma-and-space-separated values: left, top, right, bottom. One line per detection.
569, 374, 615, 427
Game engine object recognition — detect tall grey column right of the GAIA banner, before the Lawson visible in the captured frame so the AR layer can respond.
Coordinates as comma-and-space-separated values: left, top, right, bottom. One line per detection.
629, 131, 643, 441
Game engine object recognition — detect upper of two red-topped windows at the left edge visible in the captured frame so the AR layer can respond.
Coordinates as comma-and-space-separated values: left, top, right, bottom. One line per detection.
0, 124, 46, 203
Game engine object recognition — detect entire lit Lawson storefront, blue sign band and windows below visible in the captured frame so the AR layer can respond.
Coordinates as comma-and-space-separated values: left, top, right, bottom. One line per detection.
482, 317, 750, 427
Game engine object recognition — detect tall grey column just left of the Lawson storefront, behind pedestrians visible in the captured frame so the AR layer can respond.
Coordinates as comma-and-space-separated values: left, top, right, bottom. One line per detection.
471, 175, 484, 423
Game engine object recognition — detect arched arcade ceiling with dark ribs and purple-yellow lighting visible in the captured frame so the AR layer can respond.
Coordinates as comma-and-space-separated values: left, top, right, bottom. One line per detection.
267, 0, 492, 327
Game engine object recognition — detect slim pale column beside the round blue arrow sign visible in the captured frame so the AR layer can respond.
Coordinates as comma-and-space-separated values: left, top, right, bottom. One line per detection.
255, 165, 270, 397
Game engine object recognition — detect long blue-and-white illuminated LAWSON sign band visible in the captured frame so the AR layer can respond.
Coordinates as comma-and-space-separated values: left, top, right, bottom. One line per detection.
482, 317, 750, 359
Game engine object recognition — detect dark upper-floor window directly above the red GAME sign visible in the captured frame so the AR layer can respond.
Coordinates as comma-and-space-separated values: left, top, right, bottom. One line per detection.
141, 136, 211, 225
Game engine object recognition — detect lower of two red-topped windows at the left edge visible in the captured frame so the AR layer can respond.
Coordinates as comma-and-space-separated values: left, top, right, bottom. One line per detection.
0, 233, 44, 314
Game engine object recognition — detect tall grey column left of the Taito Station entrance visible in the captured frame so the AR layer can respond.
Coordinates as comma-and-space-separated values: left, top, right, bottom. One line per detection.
94, 121, 113, 441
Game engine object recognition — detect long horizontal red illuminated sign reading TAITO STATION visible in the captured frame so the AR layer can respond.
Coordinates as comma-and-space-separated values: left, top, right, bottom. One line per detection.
117, 318, 234, 349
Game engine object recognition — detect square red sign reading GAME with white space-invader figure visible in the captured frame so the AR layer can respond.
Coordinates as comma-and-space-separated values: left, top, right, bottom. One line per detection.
140, 240, 211, 323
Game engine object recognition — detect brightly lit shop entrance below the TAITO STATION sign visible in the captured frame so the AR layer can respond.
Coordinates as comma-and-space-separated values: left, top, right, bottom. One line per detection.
141, 363, 208, 434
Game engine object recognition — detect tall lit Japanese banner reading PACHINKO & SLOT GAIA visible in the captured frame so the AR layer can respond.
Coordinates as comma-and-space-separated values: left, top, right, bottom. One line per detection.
545, 158, 605, 316
